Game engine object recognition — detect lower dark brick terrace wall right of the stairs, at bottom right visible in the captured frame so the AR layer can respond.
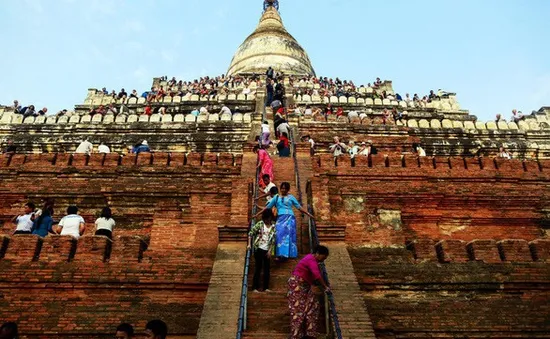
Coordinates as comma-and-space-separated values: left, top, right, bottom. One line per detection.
349, 244, 550, 339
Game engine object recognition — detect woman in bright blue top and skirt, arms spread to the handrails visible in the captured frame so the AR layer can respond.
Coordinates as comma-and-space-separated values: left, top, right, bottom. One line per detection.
254, 182, 313, 260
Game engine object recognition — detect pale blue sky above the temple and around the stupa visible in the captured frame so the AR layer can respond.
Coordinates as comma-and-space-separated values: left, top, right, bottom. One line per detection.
0, 0, 550, 120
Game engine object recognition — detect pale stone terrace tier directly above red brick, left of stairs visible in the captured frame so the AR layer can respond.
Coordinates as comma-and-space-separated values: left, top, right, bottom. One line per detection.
0, 114, 252, 154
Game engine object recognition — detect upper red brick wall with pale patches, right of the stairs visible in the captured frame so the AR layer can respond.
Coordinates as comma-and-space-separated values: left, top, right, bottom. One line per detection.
312, 154, 549, 245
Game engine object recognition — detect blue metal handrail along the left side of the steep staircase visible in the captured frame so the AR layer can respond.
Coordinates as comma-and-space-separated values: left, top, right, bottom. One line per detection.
236, 99, 266, 339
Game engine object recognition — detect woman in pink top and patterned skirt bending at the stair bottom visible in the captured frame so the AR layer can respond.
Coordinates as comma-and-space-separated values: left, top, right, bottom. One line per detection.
288, 246, 330, 339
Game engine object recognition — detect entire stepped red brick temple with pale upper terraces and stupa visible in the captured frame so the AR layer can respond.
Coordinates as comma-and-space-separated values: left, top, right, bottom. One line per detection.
0, 7, 550, 339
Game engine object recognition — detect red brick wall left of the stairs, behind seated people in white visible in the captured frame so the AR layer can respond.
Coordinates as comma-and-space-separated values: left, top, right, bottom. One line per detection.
0, 153, 249, 338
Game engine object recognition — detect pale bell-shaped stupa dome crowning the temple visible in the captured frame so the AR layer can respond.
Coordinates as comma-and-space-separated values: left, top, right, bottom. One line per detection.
227, 6, 315, 75
